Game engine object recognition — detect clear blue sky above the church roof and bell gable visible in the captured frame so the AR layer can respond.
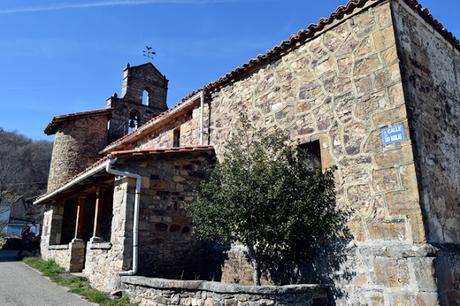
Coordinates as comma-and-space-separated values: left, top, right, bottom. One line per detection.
0, 0, 460, 140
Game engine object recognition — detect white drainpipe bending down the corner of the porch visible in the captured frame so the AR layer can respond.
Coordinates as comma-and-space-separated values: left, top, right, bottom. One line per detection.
105, 158, 141, 276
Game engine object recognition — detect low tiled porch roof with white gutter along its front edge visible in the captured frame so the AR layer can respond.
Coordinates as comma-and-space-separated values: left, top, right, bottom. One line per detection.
34, 146, 214, 204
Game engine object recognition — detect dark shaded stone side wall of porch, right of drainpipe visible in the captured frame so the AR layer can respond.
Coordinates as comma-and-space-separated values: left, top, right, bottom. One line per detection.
114, 153, 217, 279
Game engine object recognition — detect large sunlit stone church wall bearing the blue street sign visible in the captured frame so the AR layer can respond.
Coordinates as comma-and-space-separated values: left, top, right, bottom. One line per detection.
129, 1, 437, 305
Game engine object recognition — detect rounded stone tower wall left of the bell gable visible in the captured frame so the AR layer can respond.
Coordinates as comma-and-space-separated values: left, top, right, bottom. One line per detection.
48, 116, 107, 192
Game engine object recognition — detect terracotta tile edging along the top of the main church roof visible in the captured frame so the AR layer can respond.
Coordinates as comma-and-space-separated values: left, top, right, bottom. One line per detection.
99, 0, 460, 152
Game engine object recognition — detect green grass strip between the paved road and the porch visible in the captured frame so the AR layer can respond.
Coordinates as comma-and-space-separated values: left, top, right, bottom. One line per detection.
23, 257, 135, 306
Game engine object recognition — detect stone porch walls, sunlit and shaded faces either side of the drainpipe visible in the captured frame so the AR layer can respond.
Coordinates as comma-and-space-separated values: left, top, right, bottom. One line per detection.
84, 154, 214, 291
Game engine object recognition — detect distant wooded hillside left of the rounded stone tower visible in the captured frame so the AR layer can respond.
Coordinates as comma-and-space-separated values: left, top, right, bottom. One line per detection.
0, 128, 53, 200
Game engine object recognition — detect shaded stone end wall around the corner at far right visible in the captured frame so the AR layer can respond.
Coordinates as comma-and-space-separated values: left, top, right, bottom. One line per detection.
393, 1, 460, 305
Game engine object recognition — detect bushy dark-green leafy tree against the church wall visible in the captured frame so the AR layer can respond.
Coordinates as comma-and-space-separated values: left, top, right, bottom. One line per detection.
189, 117, 349, 285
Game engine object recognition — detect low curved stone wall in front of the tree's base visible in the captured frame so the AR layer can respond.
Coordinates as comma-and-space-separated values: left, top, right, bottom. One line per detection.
121, 276, 328, 306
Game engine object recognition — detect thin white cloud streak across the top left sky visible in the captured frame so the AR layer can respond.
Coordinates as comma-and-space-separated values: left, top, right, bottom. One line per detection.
0, 0, 244, 14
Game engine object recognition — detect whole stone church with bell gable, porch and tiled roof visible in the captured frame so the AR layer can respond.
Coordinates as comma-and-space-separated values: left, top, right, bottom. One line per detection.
36, 0, 460, 305
